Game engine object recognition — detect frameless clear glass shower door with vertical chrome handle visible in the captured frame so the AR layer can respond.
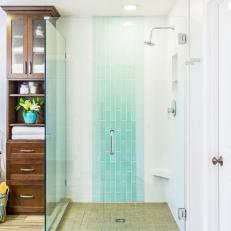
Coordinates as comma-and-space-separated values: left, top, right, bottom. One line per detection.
51, 3, 188, 231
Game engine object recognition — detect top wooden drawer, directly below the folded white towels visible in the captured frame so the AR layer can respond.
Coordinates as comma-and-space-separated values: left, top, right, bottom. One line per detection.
7, 142, 45, 158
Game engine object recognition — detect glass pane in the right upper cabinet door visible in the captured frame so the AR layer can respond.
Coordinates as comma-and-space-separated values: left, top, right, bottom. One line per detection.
32, 20, 45, 74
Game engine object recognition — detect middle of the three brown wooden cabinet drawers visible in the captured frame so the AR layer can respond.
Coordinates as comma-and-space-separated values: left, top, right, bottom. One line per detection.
7, 158, 44, 180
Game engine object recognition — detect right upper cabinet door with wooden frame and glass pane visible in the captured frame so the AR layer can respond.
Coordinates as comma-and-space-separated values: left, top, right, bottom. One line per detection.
28, 16, 45, 78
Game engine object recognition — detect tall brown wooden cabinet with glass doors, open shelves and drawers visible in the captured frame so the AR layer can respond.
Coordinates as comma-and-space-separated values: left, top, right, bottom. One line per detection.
2, 6, 60, 214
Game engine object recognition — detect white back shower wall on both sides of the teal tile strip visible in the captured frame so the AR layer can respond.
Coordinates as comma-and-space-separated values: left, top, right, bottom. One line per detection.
57, 17, 169, 202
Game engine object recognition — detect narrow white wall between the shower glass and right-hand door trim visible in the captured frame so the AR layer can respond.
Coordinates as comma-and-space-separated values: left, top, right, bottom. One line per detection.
188, 0, 205, 231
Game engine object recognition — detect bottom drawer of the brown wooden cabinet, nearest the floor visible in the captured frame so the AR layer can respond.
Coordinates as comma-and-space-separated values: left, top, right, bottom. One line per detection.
9, 185, 44, 210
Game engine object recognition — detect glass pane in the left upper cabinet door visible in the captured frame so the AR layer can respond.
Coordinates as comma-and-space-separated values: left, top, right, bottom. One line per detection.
12, 19, 24, 74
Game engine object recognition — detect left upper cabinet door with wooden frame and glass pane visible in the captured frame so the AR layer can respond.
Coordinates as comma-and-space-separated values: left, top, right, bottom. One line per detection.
7, 15, 28, 78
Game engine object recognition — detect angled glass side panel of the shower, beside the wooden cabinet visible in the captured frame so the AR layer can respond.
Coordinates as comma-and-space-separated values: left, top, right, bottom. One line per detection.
46, 21, 66, 230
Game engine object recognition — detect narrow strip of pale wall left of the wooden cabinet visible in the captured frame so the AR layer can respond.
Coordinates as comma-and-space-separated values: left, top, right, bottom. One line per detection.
0, 9, 6, 178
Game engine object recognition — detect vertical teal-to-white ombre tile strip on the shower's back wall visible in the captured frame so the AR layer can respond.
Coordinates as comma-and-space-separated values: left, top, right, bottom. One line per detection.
93, 17, 144, 202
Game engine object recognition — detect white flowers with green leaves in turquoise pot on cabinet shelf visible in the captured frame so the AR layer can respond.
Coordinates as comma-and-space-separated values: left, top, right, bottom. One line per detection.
15, 97, 43, 124
